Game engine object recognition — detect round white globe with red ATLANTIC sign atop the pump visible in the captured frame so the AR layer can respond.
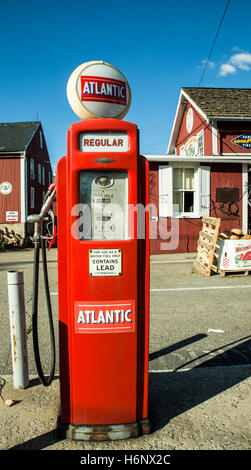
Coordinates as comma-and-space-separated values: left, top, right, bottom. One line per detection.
66, 61, 131, 121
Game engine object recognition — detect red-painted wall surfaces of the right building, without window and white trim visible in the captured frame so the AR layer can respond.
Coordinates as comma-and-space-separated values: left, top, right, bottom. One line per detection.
150, 93, 251, 254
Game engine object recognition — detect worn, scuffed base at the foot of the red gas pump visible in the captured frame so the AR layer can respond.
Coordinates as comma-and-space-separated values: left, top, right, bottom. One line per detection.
57, 417, 151, 441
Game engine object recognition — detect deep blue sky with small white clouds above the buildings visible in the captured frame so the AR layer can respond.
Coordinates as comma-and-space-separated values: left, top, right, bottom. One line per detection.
0, 0, 251, 169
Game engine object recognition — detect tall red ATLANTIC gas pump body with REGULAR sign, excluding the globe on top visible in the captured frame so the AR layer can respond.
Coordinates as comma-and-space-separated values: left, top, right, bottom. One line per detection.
56, 118, 150, 440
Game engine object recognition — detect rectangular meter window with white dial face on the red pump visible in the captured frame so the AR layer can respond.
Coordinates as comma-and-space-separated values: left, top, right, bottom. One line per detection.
79, 170, 128, 240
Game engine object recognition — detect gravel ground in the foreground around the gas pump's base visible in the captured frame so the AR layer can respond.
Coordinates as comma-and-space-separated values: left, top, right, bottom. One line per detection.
0, 366, 251, 451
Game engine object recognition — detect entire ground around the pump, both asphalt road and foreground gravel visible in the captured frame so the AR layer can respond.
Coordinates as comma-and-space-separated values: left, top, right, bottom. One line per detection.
0, 249, 251, 452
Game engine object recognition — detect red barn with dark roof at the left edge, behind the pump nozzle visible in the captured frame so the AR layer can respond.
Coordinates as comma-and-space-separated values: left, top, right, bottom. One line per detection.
0, 121, 52, 243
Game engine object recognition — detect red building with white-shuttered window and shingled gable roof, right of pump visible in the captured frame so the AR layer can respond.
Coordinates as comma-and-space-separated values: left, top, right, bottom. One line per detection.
147, 88, 251, 254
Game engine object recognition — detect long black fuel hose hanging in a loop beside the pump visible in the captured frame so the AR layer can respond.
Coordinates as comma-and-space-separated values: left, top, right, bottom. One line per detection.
32, 223, 56, 387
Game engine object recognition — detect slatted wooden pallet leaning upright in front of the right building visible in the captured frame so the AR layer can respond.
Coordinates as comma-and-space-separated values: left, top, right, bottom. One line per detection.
192, 217, 221, 276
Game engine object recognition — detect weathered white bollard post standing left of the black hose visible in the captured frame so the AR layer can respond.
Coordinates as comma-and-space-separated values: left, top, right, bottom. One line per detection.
8, 271, 29, 389
